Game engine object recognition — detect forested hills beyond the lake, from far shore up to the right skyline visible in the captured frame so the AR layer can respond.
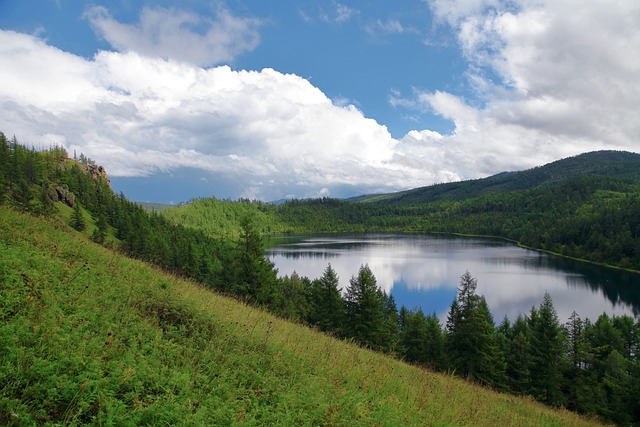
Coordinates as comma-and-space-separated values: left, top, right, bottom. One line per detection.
163, 151, 640, 270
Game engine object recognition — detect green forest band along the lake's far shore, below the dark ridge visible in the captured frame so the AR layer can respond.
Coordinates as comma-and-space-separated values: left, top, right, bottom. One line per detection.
162, 181, 640, 270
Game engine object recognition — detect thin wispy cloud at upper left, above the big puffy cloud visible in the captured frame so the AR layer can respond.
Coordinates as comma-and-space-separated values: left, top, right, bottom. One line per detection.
85, 6, 261, 66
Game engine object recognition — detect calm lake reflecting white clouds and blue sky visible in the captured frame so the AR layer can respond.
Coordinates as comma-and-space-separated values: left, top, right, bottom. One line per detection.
266, 234, 640, 323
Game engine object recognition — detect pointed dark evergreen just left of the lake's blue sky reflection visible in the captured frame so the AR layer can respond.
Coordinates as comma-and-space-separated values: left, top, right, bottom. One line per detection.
345, 265, 384, 350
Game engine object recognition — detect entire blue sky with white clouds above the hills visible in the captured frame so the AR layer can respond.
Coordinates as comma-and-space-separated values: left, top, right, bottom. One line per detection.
0, 0, 640, 203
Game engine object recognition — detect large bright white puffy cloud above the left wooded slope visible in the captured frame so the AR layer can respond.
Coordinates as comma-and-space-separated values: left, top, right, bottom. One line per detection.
0, 31, 422, 201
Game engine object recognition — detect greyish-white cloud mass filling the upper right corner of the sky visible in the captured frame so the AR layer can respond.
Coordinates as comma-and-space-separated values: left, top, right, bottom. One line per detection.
390, 0, 640, 177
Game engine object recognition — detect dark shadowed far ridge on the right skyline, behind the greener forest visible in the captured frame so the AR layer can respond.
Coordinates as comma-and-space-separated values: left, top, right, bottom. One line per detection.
351, 151, 640, 205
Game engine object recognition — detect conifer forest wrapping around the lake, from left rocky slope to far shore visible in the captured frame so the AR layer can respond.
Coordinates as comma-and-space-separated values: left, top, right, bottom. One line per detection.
0, 134, 640, 424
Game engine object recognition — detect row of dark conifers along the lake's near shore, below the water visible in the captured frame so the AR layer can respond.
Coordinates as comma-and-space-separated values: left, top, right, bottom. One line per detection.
283, 265, 640, 425
